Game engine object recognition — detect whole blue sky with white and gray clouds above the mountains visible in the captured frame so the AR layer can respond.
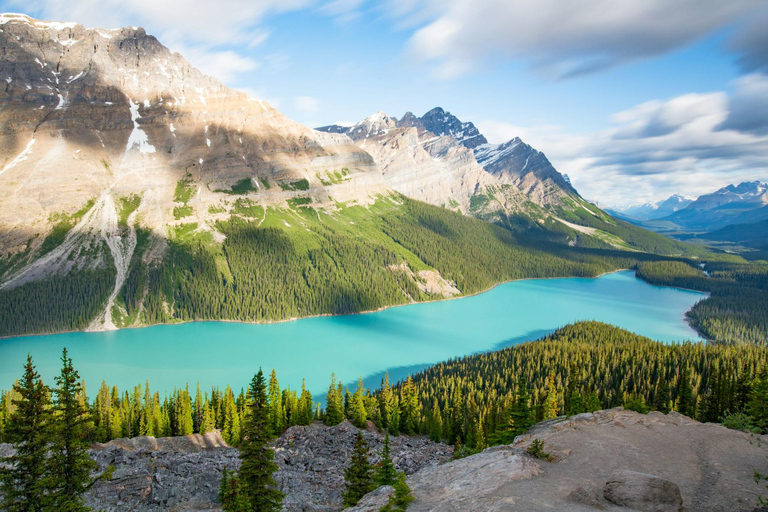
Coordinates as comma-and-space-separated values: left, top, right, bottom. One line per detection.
6, 0, 768, 206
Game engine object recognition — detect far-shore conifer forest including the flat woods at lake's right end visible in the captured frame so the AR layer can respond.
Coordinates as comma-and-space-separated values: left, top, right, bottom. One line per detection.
0, 196, 768, 343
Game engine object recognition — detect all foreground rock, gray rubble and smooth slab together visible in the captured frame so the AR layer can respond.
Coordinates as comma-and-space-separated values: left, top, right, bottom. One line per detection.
0, 408, 768, 512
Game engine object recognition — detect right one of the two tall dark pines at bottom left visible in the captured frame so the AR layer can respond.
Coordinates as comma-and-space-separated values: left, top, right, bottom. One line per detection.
48, 348, 98, 512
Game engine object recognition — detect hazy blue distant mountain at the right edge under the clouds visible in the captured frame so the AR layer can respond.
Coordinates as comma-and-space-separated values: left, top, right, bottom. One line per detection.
657, 181, 768, 231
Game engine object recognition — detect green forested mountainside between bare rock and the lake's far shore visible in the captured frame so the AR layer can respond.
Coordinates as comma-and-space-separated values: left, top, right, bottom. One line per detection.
0, 196, 760, 335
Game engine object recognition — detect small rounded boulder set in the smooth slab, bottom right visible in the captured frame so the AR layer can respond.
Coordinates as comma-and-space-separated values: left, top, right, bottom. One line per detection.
603, 471, 683, 512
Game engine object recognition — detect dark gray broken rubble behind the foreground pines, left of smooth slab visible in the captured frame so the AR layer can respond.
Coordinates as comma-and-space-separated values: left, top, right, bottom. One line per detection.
0, 422, 453, 512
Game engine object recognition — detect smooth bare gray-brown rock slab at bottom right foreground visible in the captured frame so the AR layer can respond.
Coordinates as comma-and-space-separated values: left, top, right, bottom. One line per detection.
348, 408, 768, 512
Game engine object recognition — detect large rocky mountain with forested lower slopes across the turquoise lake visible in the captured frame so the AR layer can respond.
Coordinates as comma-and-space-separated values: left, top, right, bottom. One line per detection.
0, 14, 704, 335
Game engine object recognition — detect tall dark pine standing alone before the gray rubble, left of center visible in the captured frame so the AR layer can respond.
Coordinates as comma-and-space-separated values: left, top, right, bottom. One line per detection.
238, 370, 283, 512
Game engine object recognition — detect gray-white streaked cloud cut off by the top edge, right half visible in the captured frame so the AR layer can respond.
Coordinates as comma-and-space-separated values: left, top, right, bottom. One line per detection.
390, 0, 765, 78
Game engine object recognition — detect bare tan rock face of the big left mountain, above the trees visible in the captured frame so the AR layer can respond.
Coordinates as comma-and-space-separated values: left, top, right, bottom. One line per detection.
0, 15, 390, 260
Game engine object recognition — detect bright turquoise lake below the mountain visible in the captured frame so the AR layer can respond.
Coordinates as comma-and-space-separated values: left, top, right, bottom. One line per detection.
0, 271, 706, 397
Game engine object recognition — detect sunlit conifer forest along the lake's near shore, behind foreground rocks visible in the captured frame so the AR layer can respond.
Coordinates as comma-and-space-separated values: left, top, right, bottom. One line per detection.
0, 322, 768, 450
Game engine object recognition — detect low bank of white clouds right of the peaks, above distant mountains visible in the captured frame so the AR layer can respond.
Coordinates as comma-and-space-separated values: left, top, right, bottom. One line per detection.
478, 76, 768, 205
